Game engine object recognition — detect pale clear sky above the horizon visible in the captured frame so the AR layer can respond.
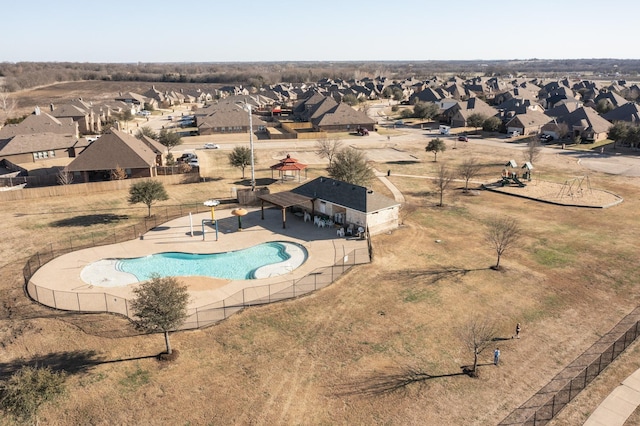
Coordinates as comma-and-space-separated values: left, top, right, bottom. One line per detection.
0, 0, 640, 63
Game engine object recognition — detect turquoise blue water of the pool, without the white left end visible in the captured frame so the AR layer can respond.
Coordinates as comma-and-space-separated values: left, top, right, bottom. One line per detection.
115, 241, 306, 281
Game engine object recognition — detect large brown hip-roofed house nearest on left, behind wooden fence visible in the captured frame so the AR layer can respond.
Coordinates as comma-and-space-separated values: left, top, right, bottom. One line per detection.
66, 129, 158, 182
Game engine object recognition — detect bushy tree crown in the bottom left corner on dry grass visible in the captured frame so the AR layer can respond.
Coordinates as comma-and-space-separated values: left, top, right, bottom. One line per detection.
0, 367, 66, 423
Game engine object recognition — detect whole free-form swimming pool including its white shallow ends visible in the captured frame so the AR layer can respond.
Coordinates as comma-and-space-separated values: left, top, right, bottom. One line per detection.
80, 241, 307, 287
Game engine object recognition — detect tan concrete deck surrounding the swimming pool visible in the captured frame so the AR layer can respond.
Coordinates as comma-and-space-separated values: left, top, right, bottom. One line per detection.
30, 208, 367, 311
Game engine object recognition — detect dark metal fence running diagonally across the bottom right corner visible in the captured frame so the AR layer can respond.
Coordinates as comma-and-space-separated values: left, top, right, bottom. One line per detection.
500, 308, 640, 426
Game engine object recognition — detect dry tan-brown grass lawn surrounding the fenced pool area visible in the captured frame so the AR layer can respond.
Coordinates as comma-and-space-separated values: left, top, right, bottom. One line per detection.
0, 82, 640, 425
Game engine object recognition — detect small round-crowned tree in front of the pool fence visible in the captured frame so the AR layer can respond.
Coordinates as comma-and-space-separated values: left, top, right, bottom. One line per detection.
131, 275, 189, 355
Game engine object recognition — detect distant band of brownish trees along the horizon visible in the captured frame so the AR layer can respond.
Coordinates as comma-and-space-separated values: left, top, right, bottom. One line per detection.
0, 59, 640, 92
